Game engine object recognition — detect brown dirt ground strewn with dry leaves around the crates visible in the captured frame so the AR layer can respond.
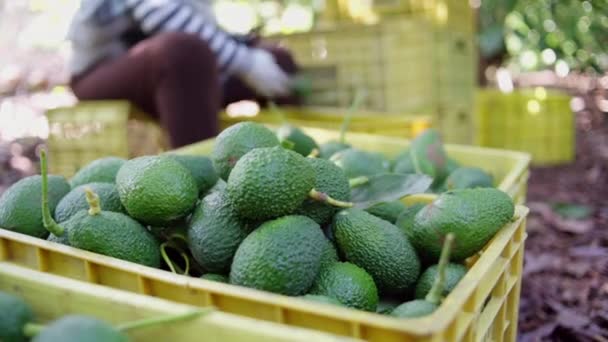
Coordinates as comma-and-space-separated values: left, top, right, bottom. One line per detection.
0, 77, 608, 341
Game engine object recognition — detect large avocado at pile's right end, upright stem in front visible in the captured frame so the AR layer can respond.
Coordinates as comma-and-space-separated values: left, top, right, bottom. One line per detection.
410, 188, 515, 262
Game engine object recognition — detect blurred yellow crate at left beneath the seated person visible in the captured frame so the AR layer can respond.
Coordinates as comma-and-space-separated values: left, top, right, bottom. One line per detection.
46, 101, 168, 177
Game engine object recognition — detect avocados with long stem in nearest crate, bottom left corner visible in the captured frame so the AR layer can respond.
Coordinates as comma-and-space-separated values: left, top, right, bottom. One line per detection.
0, 291, 204, 342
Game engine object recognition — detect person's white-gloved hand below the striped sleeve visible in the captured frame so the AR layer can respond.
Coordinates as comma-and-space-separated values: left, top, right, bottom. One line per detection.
241, 48, 291, 98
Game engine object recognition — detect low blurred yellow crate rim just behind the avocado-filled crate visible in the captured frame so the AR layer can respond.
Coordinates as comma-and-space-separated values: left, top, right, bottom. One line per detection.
220, 107, 433, 138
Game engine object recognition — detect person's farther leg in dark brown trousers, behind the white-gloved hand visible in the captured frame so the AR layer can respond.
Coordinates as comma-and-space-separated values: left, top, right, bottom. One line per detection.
222, 42, 300, 106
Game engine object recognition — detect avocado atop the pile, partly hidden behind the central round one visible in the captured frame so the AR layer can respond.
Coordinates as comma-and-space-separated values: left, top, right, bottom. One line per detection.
211, 121, 279, 180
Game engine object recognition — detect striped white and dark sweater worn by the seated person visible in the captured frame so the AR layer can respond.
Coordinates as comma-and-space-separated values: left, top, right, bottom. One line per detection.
68, 0, 250, 79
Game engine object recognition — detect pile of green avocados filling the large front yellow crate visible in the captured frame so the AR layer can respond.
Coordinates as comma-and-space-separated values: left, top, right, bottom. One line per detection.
0, 122, 514, 317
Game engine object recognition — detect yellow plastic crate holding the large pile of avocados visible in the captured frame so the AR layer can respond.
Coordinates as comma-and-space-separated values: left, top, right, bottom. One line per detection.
0, 129, 529, 341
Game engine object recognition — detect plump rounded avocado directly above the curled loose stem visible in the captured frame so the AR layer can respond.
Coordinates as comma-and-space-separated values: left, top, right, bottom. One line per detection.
116, 156, 198, 226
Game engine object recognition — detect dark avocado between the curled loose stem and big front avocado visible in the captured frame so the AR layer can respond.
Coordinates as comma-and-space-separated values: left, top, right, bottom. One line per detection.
188, 192, 254, 273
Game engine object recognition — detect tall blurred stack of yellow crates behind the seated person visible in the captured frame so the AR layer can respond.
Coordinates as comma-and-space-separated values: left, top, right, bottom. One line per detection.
270, 1, 477, 143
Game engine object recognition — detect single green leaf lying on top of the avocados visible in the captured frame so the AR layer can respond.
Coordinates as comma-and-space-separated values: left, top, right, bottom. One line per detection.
350, 173, 433, 209
